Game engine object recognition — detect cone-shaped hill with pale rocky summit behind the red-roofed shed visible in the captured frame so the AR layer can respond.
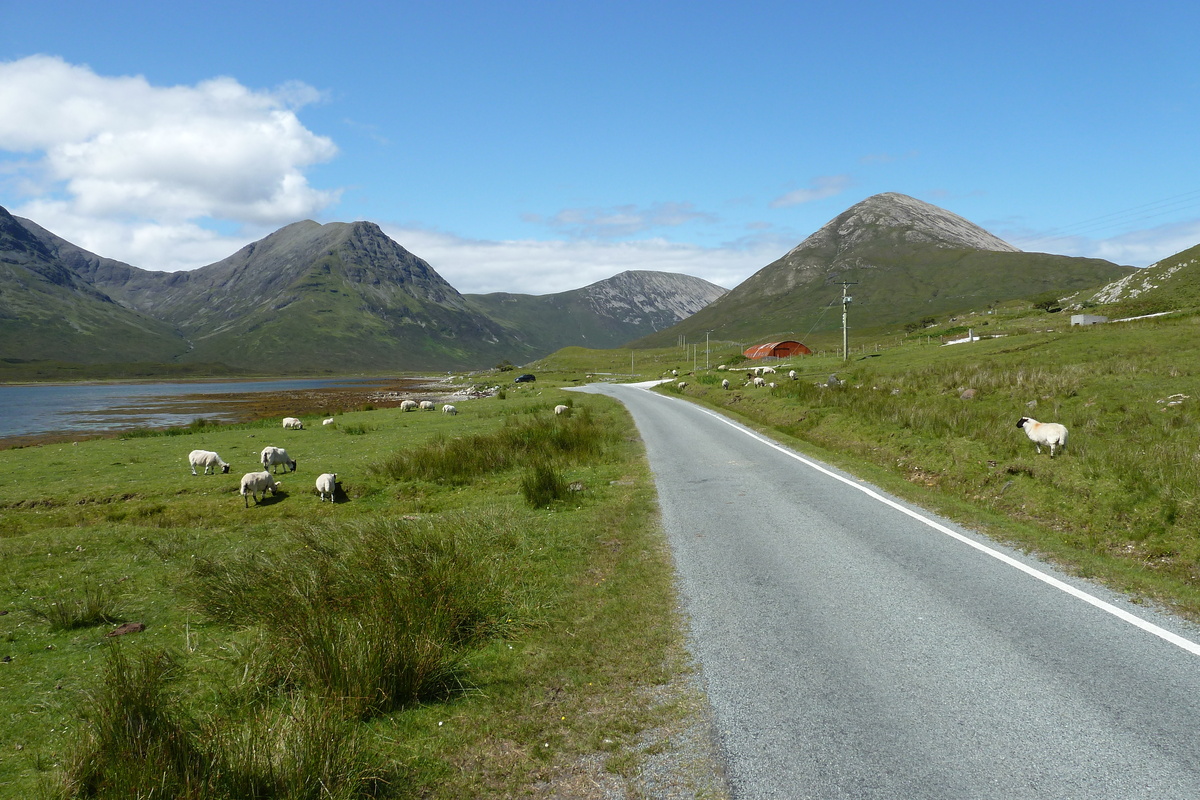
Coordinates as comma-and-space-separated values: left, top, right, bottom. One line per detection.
634, 192, 1134, 347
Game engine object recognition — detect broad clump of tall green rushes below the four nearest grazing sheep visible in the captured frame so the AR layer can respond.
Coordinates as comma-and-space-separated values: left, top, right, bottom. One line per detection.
194, 517, 517, 717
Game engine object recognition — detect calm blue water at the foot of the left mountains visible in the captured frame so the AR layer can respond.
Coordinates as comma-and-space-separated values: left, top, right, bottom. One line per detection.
0, 378, 379, 438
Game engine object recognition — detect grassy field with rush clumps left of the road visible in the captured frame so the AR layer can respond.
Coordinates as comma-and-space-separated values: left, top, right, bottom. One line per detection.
0, 387, 707, 798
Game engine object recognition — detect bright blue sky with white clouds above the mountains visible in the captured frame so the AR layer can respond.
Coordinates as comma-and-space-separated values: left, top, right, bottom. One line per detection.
0, 0, 1200, 294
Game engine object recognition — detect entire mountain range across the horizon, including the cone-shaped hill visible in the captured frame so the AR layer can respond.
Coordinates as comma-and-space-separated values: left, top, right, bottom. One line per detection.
0, 193, 1161, 374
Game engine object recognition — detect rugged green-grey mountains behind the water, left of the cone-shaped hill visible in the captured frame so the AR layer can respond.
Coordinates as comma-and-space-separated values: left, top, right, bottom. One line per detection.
0, 209, 724, 373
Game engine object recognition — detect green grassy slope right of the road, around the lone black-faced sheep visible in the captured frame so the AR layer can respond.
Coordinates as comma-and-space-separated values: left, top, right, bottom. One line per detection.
662, 317, 1200, 619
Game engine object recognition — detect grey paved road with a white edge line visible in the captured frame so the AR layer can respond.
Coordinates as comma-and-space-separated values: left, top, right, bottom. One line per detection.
587, 385, 1200, 800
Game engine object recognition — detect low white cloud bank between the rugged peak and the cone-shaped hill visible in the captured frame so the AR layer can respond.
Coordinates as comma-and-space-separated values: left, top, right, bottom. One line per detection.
382, 224, 791, 295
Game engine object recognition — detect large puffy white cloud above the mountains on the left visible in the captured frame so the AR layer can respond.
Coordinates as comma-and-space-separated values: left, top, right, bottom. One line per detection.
0, 55, 337, 269
